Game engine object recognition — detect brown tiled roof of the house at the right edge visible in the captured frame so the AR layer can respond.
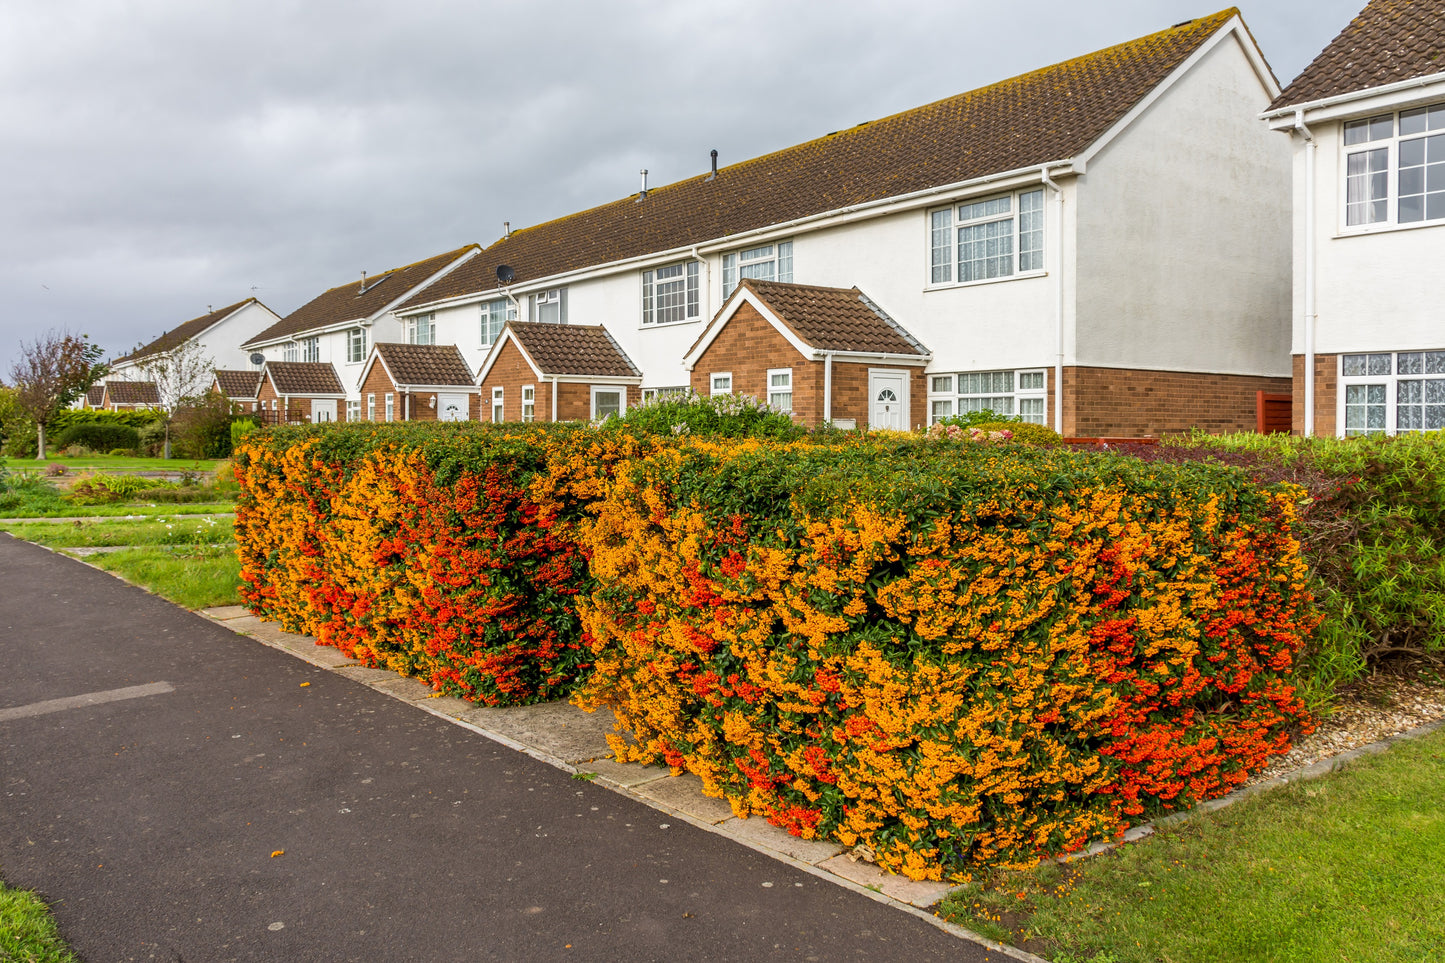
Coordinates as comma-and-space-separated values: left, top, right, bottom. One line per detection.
1269, 0, 1445, 110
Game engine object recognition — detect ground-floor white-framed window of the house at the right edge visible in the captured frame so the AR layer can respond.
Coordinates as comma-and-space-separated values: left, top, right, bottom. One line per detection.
1340, 351, 1445, 435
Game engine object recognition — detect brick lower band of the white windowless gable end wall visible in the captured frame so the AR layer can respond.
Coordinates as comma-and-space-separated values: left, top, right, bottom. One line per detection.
1049, 367, 1290, 438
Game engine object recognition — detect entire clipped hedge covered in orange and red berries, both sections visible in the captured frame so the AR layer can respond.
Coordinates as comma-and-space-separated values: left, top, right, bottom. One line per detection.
236, 425, 1315, 879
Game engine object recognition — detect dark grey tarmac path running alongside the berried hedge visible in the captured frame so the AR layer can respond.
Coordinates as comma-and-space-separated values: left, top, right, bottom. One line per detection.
0, 535, 1001, 963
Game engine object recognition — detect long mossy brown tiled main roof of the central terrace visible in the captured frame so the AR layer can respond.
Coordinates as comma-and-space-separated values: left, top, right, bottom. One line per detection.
403, 9, 1238, 308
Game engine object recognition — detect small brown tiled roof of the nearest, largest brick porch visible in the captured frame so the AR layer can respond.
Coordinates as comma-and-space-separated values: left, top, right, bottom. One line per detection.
713, 279, 928, 357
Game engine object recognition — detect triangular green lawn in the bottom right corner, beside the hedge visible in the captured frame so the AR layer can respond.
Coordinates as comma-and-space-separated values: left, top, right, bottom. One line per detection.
939, 732, 1445, 963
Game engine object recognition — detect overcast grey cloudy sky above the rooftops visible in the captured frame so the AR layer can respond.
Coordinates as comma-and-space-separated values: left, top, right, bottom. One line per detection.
0, 0, 1364, 379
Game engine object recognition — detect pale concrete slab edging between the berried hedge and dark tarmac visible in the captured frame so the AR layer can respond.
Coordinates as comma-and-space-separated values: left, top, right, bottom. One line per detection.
199, 606, 1048, 963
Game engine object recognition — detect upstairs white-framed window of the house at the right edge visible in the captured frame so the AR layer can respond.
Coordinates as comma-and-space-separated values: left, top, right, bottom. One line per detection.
1345, 104, 1445, 227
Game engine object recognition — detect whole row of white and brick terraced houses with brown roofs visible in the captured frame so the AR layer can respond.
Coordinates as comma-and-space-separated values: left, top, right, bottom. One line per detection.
94, 0, 1445, 437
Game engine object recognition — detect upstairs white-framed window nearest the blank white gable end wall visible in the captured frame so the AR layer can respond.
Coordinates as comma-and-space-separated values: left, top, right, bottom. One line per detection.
929, 188, 1043, 285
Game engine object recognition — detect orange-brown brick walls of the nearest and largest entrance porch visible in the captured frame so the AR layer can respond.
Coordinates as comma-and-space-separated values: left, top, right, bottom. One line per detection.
692, 304, 928, 427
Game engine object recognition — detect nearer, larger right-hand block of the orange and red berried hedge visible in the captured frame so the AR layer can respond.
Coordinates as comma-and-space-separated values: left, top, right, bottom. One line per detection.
575, 440, 1312, 879
